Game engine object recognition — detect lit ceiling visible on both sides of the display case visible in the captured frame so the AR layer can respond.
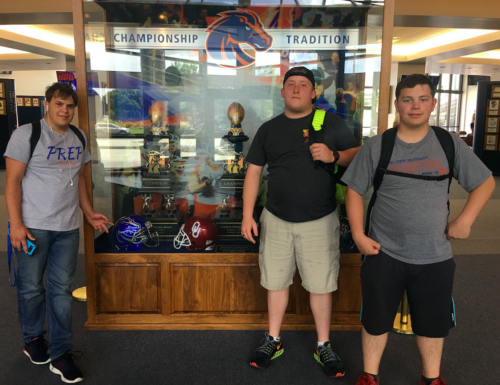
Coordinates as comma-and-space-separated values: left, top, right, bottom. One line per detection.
0, 0, 500, 75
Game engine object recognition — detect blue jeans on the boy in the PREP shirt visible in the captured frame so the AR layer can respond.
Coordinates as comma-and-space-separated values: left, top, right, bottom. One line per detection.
16, 229, 80, 359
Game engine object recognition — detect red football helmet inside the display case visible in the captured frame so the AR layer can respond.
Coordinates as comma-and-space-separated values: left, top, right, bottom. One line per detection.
174, 215, 218, 251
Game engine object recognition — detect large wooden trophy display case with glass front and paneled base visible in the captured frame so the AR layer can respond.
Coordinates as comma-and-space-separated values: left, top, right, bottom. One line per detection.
73, 0, 393, 329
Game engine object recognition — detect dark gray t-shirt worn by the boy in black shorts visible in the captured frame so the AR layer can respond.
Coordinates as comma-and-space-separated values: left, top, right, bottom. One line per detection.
342, 129, 491, 265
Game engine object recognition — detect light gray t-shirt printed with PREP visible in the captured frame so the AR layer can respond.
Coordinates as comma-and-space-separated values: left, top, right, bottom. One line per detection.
4, 119, 90, 231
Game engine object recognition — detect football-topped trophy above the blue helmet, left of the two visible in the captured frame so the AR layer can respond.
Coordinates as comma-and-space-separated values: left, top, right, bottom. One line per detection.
139, 101, 183, 241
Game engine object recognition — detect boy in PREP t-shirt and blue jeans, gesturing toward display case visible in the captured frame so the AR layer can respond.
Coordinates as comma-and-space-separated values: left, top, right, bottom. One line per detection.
4, 83, 113, 383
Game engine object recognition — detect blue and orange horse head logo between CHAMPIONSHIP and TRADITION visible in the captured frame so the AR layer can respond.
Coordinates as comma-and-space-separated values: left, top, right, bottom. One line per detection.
205, 10, 273, 68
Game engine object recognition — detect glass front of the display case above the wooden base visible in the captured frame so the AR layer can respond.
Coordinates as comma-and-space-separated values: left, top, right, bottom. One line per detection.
84, 1, 383, 253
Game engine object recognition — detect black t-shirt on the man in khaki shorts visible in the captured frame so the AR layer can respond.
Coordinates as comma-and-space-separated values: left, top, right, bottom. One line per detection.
246, 112, 359, 222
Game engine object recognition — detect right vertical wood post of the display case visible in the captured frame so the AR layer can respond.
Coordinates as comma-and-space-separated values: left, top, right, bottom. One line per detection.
377, 0, 394, 134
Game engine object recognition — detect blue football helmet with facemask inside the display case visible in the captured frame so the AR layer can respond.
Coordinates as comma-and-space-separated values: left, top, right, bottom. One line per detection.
113, 214, 160, 251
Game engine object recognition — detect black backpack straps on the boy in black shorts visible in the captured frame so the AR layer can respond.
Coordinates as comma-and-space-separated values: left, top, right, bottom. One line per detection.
365, 126, 455, 236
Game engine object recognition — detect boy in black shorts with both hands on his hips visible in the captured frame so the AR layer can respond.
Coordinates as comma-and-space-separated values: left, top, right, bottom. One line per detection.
342, 75, 495, 385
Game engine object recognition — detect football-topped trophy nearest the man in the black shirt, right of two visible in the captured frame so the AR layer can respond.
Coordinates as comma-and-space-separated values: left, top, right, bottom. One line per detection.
214, 102, 248, 240
